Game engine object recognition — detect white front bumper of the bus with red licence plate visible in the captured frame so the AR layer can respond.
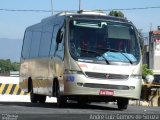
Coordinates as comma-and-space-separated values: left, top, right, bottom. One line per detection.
62, 75, 141, 99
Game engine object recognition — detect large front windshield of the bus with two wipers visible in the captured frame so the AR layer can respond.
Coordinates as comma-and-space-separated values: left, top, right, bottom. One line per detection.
69, 19, 140, 64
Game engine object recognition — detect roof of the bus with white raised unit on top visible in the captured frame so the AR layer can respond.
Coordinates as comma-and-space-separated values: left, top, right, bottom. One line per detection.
27, 11, 132, 30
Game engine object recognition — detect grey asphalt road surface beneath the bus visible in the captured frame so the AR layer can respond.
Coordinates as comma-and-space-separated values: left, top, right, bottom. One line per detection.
0, 102, 160, 120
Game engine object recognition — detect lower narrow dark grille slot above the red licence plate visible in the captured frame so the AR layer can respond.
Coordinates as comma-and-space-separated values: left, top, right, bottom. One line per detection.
83, 83, 129, 90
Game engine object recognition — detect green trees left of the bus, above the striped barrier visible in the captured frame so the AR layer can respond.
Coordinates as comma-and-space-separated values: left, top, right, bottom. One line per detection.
0, 59, 19, 73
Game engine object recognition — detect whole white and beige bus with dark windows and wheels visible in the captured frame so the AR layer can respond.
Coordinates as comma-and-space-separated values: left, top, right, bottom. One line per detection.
20, 13, 142, 109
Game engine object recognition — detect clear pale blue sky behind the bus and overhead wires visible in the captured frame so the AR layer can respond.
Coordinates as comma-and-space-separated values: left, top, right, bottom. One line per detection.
0, 0, 160, 39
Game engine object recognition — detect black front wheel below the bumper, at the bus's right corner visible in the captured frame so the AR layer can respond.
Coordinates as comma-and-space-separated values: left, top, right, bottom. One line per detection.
117, 98, 129, 110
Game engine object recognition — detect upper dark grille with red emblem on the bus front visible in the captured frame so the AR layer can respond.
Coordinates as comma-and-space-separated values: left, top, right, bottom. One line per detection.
85, 72, 129, 79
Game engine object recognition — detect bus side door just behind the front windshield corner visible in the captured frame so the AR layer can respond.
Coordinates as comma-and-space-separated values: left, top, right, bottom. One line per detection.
49, 24, 64, 94
